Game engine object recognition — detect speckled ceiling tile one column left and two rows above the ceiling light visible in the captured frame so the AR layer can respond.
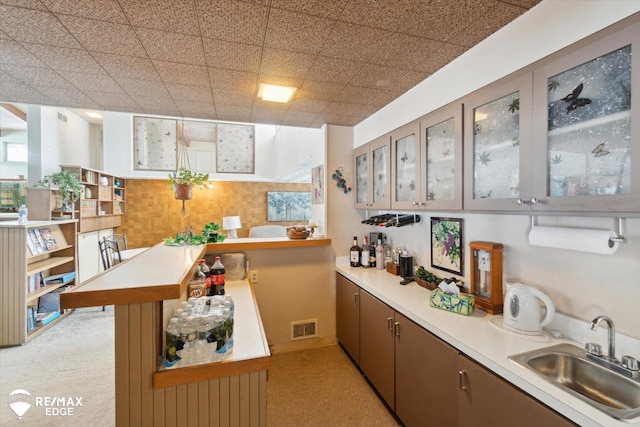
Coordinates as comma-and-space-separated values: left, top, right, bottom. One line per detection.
196, 0, 269, 45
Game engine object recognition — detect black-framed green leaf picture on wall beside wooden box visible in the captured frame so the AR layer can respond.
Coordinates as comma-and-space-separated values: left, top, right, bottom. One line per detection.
431, 217, 464, 275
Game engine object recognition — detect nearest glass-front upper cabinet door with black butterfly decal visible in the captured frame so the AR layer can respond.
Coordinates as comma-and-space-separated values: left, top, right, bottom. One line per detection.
533, 17, 640, 212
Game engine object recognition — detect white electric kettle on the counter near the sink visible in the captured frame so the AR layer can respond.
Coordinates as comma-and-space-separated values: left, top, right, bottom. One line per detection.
504, 283, 556, 335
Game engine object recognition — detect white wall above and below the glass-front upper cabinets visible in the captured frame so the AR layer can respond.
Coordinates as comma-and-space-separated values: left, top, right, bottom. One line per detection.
344, 0, 640, 338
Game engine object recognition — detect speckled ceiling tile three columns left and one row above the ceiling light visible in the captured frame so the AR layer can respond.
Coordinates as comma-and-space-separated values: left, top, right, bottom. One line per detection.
58, 15, 146, 57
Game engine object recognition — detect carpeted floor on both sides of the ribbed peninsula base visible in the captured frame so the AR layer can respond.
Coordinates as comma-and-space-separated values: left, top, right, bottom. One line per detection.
0, 306, 398, 427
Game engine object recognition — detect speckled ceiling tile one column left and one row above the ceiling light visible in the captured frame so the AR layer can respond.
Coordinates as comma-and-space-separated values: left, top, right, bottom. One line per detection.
202, 38, 262, 73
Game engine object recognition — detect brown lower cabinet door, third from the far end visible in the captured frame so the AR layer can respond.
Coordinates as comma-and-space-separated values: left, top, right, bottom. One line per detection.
395, 313, 458, 427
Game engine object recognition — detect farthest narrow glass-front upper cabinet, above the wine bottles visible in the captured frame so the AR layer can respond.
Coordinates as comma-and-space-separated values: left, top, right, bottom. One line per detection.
353, 135, 391, 209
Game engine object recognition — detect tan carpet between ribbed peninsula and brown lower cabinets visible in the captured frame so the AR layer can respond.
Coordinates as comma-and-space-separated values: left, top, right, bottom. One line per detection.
267, 345, 398, 427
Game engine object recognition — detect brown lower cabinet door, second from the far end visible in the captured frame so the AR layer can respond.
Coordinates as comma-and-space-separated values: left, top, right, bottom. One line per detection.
360, 289, 395, 410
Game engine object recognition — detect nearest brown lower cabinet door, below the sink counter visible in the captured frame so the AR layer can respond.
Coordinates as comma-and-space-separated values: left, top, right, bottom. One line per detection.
458, 355, 574, 427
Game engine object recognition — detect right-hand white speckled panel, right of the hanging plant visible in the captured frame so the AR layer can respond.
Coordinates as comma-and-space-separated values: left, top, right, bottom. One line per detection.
216, 123, 255, 173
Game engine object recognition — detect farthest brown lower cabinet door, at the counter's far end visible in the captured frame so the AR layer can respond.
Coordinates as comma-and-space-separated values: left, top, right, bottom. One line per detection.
336, 273, 360, 364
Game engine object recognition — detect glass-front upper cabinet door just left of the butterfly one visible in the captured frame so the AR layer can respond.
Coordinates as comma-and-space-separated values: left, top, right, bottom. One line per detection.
464, 72, 533, 211
